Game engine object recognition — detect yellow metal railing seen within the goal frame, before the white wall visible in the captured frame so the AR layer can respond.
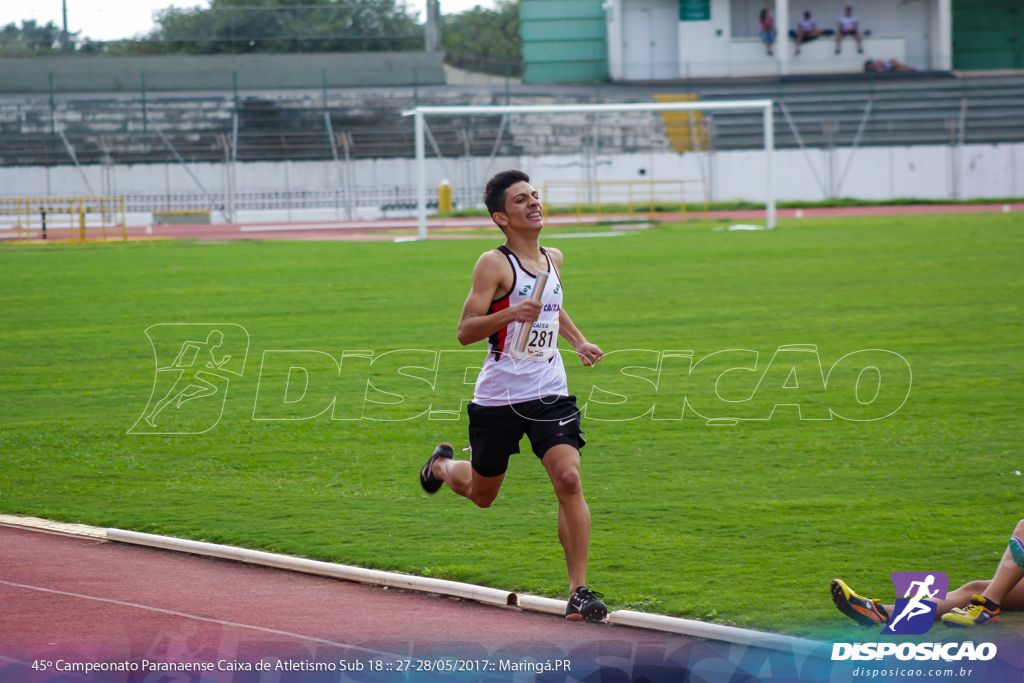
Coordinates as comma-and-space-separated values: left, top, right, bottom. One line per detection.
541, 179, 708, 222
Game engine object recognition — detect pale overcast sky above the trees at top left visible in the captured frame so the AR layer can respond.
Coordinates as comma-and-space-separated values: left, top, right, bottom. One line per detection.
0, 0, 495, 40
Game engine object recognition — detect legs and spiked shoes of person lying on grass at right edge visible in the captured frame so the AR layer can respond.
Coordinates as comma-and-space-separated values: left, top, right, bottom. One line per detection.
830, 519, 1024, 628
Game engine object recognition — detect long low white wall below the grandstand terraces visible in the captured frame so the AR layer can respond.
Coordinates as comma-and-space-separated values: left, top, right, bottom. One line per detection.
0, 143, 1024, 224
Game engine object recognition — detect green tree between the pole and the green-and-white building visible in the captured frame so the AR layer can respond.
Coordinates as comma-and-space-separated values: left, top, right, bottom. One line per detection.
441, 0, 522, 75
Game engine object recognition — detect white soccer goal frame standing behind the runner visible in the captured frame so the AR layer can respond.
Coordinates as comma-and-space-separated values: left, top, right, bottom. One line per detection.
402, 99, 775, 240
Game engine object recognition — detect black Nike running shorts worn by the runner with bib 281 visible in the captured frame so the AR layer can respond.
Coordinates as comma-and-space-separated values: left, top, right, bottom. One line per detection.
466, 396, 587, 477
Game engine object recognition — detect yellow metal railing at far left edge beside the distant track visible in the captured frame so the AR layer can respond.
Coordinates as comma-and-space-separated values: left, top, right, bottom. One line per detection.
0, 197, 128, 243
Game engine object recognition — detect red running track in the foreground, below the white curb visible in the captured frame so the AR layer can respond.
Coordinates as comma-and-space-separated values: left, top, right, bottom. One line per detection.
0, 525, 782, 683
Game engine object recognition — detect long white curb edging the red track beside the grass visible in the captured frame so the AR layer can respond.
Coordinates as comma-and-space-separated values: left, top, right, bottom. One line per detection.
0, 515, 826, 655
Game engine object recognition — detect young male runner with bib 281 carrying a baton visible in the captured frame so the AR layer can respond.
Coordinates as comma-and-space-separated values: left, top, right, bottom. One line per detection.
420, 171, 607, 622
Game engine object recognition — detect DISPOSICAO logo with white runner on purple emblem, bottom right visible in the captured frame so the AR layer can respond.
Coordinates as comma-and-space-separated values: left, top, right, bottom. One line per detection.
831, 571, 997, 661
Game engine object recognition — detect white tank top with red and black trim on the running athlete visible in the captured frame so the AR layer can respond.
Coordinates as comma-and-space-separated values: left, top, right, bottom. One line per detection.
473, 245, 568, 405
